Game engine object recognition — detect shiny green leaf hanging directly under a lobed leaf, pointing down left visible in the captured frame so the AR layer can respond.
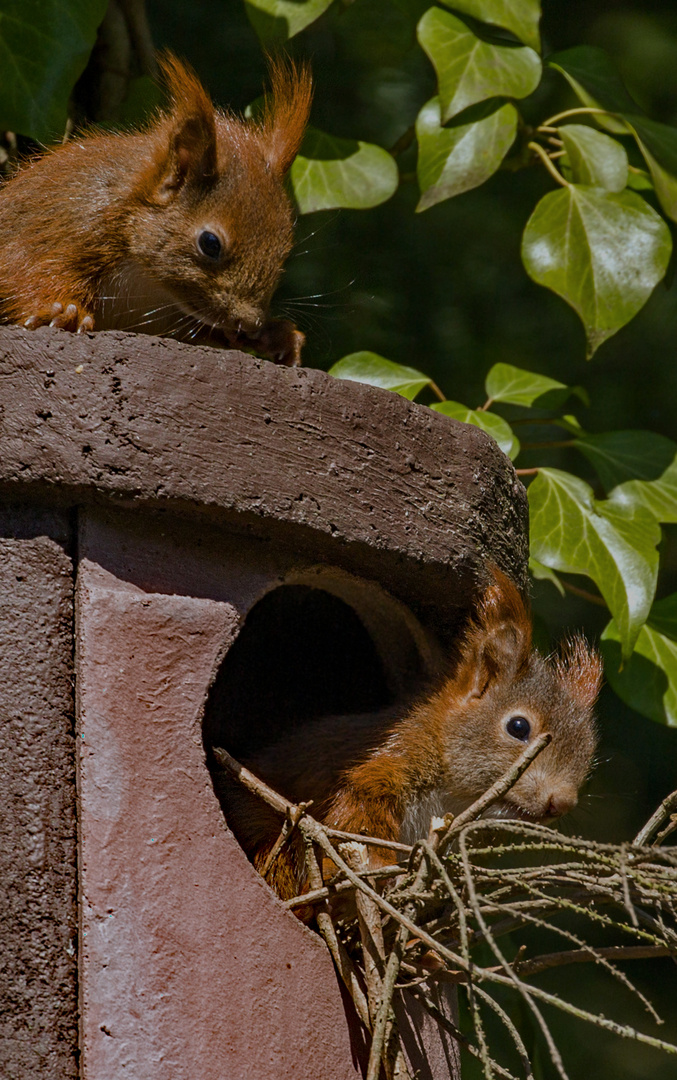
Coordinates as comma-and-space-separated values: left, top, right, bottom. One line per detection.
416, 97, 517, 211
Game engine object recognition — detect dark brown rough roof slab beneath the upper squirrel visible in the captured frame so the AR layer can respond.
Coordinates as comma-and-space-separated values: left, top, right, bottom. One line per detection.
0, 327, 527, 606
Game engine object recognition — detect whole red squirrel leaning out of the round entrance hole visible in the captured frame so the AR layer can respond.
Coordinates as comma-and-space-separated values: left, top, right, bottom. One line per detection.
221, 569, 601, 900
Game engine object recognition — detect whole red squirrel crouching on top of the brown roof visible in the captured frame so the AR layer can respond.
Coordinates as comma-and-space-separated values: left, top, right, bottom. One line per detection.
0, 55, 311, 366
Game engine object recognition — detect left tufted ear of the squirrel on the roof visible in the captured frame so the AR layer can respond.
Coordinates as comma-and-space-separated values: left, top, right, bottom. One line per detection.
155, 53, 216, 198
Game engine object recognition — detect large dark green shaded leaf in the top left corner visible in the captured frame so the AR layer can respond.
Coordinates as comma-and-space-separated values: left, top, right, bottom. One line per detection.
0, 0, 108, 143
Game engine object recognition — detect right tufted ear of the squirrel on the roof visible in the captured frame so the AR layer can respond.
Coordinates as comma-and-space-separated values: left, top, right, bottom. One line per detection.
259, 57, 313, 176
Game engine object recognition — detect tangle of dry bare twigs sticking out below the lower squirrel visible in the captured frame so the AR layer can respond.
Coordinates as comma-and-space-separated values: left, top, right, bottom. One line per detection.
215, 735, 677, 1080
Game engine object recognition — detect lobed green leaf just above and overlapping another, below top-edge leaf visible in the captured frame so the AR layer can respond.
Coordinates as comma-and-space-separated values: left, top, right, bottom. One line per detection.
418, 8, 542, 123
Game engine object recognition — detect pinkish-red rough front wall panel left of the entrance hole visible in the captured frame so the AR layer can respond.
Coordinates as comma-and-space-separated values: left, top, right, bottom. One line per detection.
78, 520, 367, 1080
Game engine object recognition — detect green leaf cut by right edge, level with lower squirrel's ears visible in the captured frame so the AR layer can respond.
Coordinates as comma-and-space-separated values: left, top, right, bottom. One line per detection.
600, 609, 677, 727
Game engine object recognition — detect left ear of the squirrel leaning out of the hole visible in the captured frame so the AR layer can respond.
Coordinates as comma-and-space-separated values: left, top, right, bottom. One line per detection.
456, 565, 531, 698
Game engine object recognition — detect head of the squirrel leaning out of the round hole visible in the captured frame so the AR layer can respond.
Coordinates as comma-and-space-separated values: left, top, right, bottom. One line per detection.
436, 568, 601, 821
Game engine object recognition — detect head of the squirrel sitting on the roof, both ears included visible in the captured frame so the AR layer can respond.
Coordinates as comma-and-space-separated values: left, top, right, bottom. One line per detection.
124, 55, 312, 339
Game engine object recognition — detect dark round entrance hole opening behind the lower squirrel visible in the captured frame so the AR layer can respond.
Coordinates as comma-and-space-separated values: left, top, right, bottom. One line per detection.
204, 583, 437, 876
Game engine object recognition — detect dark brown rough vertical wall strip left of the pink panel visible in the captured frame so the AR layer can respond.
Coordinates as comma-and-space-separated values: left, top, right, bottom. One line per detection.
0, 507, 78, 1080
